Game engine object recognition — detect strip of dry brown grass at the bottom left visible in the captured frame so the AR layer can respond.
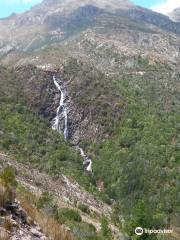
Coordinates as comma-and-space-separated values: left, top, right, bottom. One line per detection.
17, 193, 76, 240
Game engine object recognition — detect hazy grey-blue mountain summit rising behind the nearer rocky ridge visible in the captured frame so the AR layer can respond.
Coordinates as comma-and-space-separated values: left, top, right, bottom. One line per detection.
0, 0, 180, 63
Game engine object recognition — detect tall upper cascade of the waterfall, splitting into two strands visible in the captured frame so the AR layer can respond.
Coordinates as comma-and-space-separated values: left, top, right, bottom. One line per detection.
52, 76, 68, 139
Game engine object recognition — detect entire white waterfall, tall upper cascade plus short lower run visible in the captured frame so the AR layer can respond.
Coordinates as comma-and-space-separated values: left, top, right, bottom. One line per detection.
52, 76, 92, 173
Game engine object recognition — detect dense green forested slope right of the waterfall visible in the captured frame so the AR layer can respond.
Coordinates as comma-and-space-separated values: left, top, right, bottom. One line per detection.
84, 58, 180, 239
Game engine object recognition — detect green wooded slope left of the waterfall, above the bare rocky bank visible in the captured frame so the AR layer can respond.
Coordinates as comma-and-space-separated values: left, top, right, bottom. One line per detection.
0, 67, 88, 184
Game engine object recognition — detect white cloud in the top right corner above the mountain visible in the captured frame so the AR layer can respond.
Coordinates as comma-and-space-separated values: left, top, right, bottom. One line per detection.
151, 0, 180, 14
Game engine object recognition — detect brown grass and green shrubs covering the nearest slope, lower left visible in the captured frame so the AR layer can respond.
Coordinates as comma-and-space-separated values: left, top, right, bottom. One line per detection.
0, 167, 112, 240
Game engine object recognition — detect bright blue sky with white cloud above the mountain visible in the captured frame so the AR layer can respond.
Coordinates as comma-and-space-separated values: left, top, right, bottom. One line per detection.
0, 0, 180, 18
